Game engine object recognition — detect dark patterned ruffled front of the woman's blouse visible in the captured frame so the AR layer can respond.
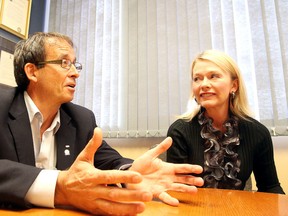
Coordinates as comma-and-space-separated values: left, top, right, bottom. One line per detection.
198, 111, 242, 189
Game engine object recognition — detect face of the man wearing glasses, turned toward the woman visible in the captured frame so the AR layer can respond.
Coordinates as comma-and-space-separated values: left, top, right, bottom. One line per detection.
35, 38, 79, 105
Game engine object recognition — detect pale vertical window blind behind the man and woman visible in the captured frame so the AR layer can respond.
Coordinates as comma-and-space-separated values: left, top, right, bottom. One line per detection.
48, 0, 288, 137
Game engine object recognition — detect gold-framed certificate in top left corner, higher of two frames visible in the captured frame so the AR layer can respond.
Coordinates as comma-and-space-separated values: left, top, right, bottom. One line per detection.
0, 0, 32, 39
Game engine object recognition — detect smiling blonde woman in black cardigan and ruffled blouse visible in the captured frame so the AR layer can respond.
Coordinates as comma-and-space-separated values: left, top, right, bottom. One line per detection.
167, 50, 284, 194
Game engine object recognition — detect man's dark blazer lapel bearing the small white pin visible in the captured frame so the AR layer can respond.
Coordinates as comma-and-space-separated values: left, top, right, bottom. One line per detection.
56, 109, 77, 170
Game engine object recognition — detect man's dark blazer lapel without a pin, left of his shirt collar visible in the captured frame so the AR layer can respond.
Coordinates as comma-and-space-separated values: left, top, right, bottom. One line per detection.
8, 93, 35, 166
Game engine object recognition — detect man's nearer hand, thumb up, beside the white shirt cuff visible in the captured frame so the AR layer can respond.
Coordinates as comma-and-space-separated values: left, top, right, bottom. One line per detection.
55, 128, 153, 215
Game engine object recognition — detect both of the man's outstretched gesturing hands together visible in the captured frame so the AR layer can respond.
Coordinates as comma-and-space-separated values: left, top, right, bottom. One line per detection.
55, 128, 203, 215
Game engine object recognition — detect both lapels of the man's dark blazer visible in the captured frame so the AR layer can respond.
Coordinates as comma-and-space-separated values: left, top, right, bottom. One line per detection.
8, 93, 77, 170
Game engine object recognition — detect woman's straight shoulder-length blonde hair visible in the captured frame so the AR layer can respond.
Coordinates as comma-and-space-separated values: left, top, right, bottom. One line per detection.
179, 50, 251, 120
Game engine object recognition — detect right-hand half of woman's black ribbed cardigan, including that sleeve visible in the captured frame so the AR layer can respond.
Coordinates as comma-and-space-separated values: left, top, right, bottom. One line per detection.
239, 119, 284, 194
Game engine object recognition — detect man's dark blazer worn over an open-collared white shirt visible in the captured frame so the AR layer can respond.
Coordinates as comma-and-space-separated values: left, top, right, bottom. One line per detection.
0, 84, 132, 207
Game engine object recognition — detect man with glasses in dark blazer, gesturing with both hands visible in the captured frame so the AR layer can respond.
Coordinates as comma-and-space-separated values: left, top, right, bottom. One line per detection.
0, 32, 203, 215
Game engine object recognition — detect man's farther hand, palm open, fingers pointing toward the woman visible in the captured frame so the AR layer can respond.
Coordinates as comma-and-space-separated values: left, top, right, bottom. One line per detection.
128, 137, 204, 206
